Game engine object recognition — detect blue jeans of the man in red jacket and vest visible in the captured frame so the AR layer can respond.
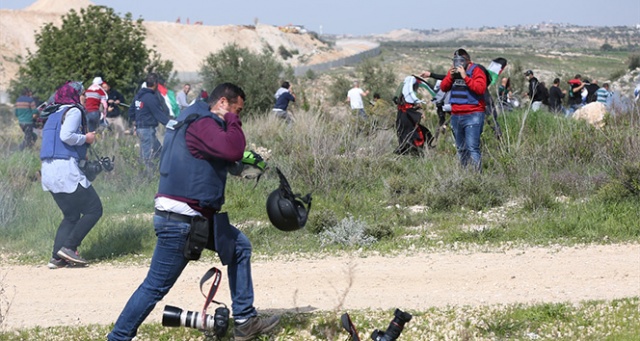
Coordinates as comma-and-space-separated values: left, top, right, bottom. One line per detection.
451, 111, 484, 170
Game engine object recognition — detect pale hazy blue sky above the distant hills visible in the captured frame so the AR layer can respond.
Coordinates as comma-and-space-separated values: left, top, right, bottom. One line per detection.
0, 0, 640, 35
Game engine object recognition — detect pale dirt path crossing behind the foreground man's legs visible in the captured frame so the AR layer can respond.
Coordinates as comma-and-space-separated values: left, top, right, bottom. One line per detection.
0, 244, 640, 329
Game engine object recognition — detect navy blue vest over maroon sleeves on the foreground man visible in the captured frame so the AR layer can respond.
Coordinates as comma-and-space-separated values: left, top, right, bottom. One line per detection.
158, 101, 230, 210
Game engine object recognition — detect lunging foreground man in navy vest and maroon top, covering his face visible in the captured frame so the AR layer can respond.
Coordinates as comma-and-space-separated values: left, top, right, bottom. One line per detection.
108, 83, 279, 341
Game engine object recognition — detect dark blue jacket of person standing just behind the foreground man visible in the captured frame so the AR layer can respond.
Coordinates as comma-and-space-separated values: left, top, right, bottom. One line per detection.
129, 88, 169, 128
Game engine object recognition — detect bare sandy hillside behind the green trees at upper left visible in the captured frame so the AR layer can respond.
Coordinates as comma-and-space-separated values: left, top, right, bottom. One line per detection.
0, 0, 371, 92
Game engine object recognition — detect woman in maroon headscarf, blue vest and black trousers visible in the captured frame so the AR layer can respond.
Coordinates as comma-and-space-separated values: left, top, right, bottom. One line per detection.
40, 82, 102, 269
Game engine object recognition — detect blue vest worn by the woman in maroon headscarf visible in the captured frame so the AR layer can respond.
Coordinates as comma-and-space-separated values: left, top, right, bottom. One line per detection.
40, 106, 88, 160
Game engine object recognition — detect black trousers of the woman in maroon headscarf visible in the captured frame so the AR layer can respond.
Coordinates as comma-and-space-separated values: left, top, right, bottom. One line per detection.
51, 185, 102, 258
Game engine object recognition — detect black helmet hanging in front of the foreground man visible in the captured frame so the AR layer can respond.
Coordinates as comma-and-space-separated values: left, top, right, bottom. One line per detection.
267, 167, 311, 232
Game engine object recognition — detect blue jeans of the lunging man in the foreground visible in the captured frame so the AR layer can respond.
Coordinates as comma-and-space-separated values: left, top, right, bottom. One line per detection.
107, 216, 257, 341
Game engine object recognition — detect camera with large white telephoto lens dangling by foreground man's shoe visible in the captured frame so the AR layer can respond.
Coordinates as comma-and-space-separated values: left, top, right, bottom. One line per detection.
162, 305, 229, 338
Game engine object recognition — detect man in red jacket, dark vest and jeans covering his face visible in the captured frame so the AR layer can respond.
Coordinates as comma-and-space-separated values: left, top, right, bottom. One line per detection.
440, 49, 487, 170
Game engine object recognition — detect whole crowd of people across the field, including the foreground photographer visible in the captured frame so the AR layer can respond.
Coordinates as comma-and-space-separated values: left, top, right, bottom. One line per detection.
8, 48, 640, 341
